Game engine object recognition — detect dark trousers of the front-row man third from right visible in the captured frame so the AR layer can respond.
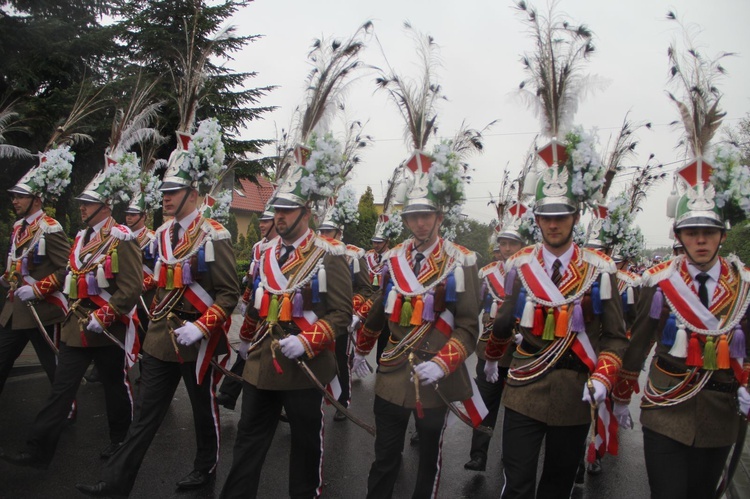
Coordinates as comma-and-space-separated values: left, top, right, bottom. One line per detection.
367, 395, 448, 499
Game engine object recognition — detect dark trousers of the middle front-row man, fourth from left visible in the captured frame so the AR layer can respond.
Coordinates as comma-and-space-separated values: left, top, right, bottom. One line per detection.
220, 383, 323, 499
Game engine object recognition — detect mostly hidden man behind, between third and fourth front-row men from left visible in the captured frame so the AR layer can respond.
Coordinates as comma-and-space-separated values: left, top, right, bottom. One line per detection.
216, 206, 277, 409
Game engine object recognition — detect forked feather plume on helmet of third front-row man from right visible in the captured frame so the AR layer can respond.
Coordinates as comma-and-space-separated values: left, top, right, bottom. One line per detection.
375, 22, 445, 151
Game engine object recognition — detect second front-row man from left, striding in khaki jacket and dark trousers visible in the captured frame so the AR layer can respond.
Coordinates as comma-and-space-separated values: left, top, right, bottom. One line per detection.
4, 158, 141, 468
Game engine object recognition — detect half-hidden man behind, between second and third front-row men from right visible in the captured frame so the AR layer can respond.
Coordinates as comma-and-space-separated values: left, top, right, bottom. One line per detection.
464, 202, 527, 471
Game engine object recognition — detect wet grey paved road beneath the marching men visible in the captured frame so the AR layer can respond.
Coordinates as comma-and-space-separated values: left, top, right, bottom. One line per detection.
0, 318, 649, 499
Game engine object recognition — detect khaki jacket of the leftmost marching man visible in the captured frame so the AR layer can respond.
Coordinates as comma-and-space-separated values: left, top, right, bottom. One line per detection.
0, 215, 70, 329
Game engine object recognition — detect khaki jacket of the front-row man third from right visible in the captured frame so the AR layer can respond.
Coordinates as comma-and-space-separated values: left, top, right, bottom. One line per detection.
358, 239, 480, 409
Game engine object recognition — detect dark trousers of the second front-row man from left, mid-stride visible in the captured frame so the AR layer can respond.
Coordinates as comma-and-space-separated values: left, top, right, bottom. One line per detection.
28, 343, 133, 462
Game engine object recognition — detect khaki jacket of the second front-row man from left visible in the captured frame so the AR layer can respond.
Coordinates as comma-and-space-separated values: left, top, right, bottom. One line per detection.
61, 217, 143, 347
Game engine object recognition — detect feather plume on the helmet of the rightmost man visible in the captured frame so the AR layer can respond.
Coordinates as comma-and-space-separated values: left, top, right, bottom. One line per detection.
667, 12, 735, 157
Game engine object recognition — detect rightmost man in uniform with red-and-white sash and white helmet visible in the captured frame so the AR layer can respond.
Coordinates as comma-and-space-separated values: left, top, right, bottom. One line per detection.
613, 161, 750, 497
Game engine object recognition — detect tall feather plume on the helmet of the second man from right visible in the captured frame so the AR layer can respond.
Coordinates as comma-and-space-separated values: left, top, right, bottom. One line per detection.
516, 1, 594, 138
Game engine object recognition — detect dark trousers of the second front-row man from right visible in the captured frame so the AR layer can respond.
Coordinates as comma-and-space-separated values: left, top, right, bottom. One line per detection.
501, 407, 590, 499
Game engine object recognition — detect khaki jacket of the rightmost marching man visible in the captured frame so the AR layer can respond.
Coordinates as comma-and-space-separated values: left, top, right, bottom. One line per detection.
622, 259, 750, 447
